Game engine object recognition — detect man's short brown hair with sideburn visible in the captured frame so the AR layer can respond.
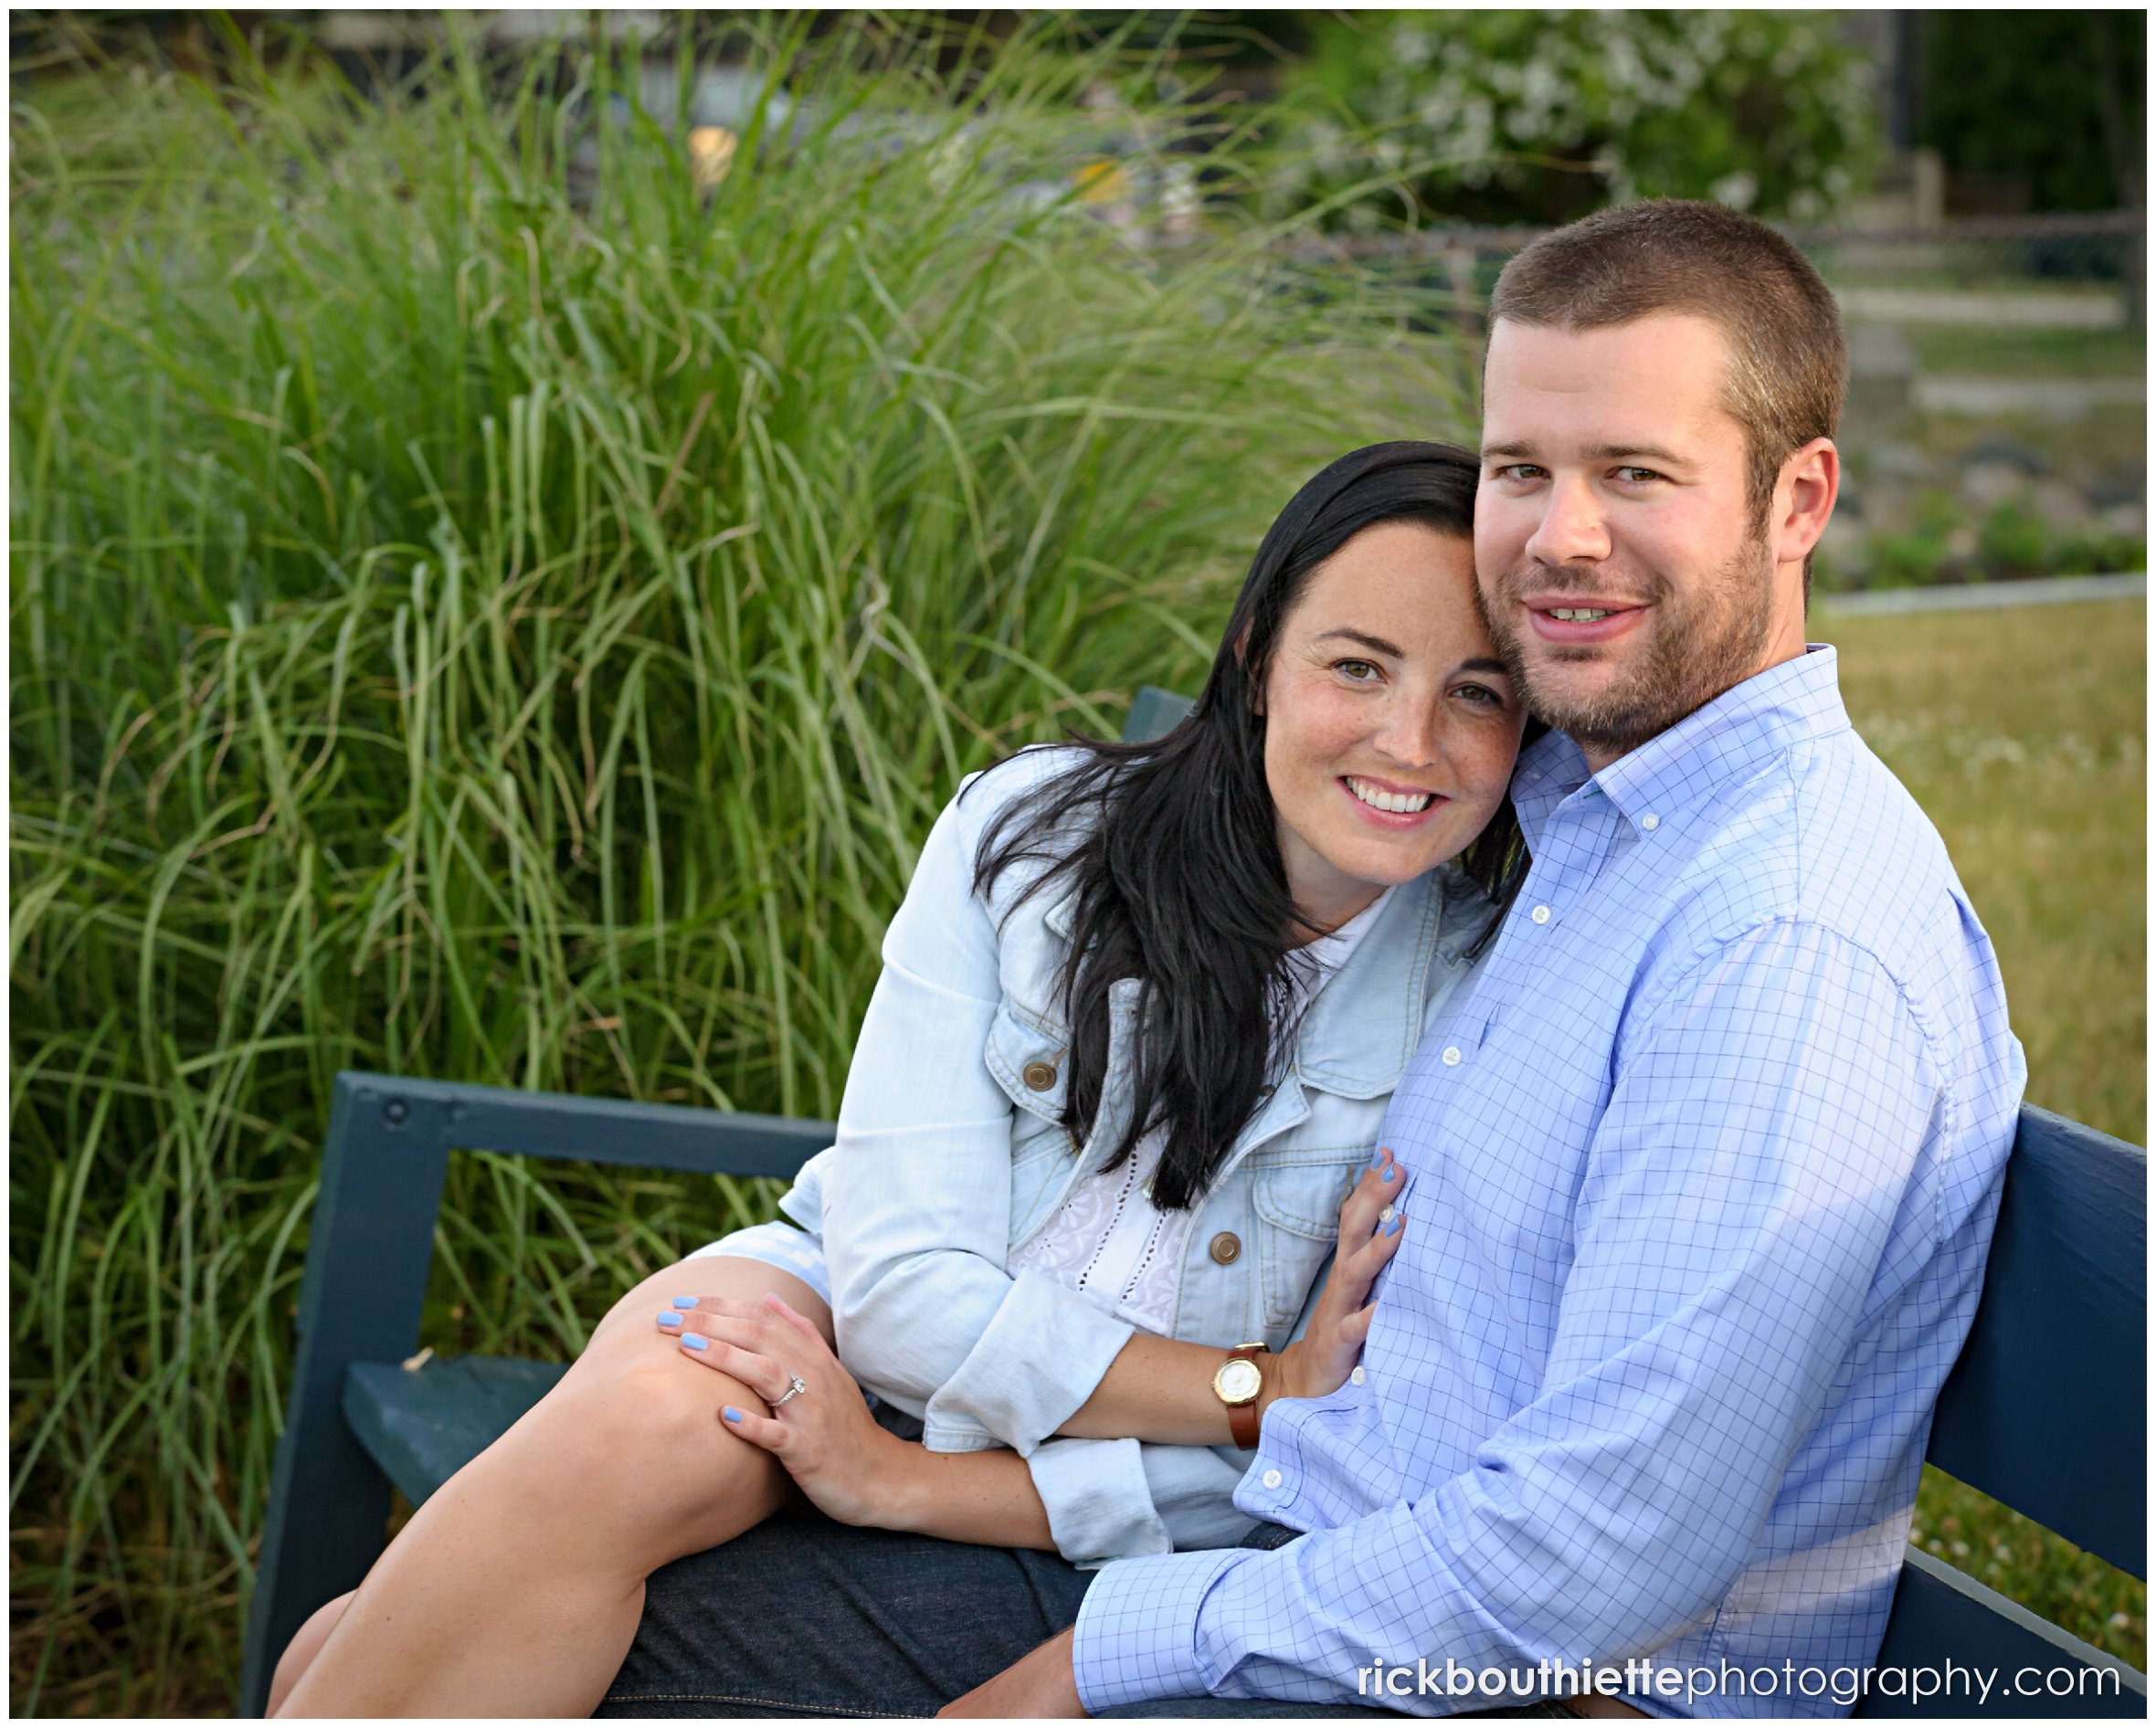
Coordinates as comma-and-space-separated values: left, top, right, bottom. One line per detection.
1490, 198, 1850, 525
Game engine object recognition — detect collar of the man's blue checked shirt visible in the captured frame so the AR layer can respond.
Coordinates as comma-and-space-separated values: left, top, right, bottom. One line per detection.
1511, 642, 1850, 851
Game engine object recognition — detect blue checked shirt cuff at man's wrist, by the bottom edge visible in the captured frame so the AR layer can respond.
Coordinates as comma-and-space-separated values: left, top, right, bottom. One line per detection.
1072, 1549, 1255, 1715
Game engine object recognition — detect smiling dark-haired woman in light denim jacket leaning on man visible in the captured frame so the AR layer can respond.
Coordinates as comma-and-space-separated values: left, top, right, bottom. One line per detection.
274, 444, 1522, 1715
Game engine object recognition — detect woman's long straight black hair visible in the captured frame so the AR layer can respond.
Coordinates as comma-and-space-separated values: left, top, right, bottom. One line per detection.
975, 442, 1527, 1211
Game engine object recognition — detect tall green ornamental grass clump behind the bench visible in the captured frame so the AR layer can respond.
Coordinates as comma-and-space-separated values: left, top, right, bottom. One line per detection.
8, 16, 1436, 1712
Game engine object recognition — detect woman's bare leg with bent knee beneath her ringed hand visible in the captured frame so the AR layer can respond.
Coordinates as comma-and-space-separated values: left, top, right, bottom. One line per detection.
271, 1256, 830, 1717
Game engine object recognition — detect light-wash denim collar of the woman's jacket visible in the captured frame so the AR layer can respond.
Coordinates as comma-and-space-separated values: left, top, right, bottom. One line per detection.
1041, 864, 1448, 1099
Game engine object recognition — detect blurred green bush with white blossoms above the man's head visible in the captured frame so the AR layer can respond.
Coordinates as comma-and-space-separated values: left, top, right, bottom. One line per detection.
1268, 8, 1878, 228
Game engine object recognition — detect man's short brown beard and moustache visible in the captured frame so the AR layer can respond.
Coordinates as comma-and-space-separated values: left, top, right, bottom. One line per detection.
1487, 532, 1774, 761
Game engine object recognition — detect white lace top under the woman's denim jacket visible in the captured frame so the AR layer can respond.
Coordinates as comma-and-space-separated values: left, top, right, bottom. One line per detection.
1005, 888, 1393, 1336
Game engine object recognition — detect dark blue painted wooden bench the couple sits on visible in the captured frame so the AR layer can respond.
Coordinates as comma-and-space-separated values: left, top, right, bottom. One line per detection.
239, 690, 2148, 1717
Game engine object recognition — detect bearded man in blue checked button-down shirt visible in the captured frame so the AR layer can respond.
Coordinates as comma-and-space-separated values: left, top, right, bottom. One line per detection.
603, 203, 2024, 1715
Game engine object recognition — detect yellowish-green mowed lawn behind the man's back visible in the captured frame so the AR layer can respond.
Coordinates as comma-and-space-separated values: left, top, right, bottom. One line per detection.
1811, 601, 2148, 1670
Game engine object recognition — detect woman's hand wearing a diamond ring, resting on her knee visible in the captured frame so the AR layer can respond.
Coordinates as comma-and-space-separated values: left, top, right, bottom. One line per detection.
660, 1295, 912, 1523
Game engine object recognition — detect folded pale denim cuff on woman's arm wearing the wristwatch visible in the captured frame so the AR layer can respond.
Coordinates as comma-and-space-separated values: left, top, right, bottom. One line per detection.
923, 1271, 1136, 1457
